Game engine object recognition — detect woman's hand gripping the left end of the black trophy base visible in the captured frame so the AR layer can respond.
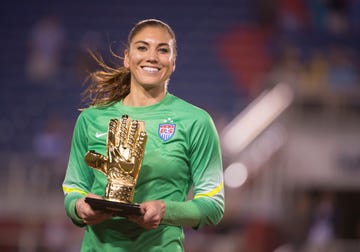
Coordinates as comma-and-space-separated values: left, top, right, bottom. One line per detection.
75, 193, 112, 225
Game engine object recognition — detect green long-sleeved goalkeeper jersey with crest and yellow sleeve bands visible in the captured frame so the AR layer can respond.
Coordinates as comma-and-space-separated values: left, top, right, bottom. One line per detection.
63, 93, 224, 251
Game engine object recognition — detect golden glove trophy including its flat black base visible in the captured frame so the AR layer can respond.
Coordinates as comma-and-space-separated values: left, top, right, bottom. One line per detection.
85, 115, 147, 216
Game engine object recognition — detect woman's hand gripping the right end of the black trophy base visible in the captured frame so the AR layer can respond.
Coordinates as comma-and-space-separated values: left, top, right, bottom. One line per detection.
128, 200, 165, 229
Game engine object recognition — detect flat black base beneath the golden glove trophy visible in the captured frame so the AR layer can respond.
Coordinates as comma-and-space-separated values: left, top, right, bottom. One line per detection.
85, 197, 142, 217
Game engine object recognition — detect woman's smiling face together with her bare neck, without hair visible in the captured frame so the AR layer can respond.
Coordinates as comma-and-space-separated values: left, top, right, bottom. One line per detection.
124, 26, 176, 106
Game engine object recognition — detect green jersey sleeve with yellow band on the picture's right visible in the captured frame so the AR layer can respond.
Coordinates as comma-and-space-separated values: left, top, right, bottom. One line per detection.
163, 114, 224, 228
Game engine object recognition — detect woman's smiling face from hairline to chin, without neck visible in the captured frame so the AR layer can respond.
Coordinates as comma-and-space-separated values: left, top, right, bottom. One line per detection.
124, 26, 176, 89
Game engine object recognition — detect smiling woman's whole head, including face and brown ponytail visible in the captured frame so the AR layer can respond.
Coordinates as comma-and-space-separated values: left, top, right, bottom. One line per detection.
82, 19, 177, 105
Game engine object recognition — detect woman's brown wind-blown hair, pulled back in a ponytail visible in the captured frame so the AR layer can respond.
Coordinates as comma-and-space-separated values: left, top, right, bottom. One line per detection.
82, 19, 177, 106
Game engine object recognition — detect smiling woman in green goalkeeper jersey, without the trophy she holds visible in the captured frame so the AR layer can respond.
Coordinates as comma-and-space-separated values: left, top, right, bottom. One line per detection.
63, 19, 224, 251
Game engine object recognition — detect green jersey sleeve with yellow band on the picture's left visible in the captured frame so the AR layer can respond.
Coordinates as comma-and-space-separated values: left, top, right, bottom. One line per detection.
62, 114, 94, 226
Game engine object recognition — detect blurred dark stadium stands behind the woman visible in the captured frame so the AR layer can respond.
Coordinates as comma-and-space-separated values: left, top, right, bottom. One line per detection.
0, 0, 360, 252
